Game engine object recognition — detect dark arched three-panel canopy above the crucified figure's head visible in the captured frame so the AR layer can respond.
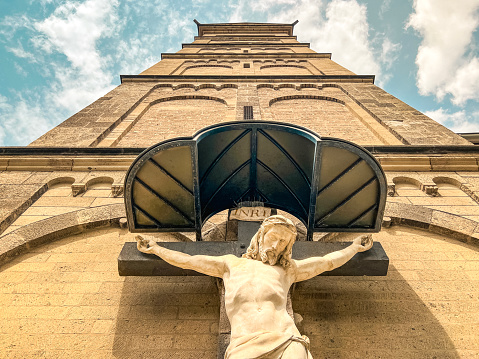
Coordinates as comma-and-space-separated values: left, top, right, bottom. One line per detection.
125, 121, 386, 240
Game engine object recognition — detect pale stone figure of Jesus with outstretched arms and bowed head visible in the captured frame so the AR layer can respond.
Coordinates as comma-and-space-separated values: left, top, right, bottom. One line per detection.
136, 215, 373, 359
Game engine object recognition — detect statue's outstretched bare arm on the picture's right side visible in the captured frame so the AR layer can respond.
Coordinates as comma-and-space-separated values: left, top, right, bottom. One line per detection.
295, 234, 373, 282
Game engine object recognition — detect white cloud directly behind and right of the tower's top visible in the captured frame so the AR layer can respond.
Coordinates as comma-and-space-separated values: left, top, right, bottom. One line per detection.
230, 0, 400, 85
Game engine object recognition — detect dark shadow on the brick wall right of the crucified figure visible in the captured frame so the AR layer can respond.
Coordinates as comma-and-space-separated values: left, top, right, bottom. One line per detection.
293, 265, 459, 359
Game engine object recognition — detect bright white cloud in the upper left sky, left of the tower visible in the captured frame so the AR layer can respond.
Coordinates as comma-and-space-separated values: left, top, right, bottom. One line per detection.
33, 0, 118, 110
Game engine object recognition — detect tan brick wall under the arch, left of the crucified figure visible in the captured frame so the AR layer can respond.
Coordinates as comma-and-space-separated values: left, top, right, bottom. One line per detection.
0, 230, 219, 359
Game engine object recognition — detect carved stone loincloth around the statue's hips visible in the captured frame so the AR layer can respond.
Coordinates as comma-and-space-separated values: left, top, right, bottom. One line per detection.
225, 332, 312, 359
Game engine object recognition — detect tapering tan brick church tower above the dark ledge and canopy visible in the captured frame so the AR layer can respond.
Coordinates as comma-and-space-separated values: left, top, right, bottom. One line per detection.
31, 23, 470, 147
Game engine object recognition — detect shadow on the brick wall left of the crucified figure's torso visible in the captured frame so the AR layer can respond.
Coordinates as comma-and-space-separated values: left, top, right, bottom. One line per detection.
113, 277, 220, 359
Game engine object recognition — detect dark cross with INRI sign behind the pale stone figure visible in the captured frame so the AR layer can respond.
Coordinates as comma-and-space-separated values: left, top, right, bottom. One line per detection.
118, 208, 389, 359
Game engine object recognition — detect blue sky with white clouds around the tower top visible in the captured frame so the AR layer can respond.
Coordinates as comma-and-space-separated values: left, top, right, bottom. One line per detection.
0, 0, 479, 146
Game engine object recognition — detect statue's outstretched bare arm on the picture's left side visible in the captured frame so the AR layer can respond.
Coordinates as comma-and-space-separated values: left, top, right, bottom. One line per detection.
135, 236, 227, 278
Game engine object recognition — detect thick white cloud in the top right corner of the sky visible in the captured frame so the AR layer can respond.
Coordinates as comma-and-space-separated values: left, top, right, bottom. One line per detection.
406, 0, 479, 105
